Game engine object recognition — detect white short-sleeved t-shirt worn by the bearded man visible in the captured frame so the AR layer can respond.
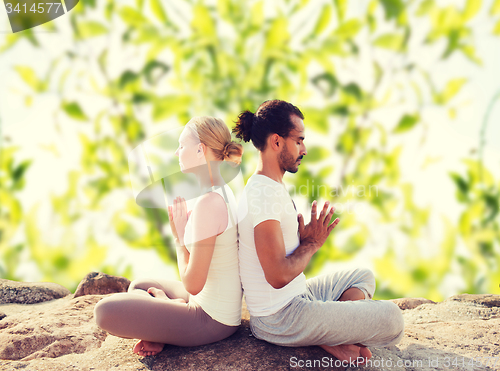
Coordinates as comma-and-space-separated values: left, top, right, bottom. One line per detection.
238, 174, 306, 317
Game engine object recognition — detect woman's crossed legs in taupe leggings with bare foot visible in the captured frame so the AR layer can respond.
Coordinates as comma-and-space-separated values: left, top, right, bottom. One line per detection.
94, 280, 237, 355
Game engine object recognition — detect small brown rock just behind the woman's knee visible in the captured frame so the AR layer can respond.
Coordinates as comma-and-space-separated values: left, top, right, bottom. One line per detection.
74, 272, 130, 298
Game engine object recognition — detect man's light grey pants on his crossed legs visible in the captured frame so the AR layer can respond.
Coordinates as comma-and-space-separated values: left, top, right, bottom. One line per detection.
250, 269, 404, 347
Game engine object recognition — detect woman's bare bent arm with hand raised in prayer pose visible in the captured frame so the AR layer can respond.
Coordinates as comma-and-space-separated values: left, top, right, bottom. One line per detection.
170, 192, 228, 295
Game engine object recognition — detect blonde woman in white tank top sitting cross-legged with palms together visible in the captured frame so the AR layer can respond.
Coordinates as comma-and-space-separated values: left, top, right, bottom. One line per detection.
95, 117, 243, 356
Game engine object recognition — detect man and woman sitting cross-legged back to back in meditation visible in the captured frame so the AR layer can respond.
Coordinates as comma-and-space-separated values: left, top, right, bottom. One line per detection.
95, 100, 404, 364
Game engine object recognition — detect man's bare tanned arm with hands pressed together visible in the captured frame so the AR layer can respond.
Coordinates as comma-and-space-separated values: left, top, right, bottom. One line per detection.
254, 201, 339, 289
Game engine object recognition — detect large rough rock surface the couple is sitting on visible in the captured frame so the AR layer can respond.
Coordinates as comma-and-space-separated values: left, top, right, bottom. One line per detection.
0, 280, 500, 371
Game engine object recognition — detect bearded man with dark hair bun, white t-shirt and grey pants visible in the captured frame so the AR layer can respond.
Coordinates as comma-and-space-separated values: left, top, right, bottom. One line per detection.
233, 100, 404, 364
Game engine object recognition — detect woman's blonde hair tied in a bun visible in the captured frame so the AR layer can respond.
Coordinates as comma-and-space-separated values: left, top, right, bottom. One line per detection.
186, 116, 243, 164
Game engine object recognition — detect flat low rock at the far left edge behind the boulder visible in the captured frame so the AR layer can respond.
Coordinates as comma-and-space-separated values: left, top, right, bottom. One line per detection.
0, 278, 71, 304
